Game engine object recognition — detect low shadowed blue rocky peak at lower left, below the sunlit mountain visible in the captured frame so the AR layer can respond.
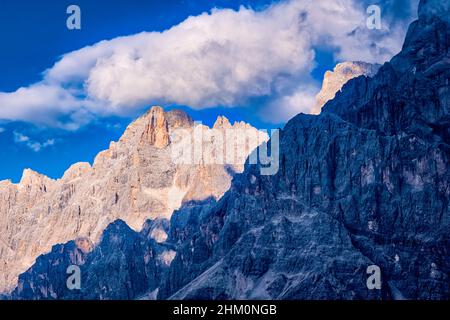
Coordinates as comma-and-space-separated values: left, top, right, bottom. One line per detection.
11, 220, 172, 299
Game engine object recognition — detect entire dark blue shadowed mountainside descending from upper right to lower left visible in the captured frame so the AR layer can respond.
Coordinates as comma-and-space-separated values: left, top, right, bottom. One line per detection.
7, 0, 450, 299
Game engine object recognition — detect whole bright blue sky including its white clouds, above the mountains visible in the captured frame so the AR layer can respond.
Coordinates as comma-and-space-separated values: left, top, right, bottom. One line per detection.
0, 0, 417, 181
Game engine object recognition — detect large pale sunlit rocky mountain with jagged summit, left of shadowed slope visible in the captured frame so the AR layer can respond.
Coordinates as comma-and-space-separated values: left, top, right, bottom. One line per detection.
0, 107, 268, 292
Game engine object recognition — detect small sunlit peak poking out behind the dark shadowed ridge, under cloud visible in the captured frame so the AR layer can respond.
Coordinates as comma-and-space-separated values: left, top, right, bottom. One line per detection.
311, 61, 380, 114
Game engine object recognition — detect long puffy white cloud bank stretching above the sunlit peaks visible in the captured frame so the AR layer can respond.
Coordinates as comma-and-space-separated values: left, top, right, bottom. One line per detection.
0, 0, 414, 129
